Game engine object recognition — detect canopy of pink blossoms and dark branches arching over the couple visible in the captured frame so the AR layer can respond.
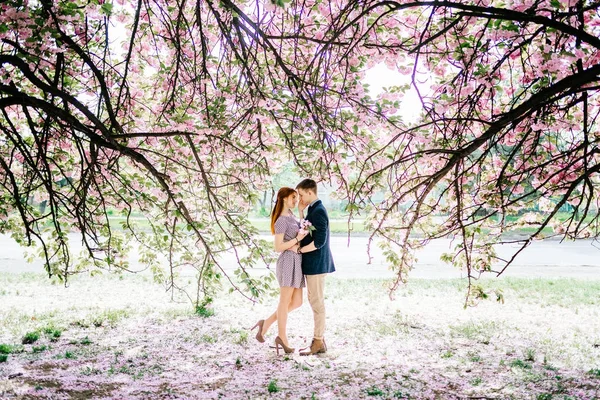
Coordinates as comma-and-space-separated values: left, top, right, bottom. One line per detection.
0, 0, 600, 301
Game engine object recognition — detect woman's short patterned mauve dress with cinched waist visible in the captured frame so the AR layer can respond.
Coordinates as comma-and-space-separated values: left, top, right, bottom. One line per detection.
275, 215, 306, 288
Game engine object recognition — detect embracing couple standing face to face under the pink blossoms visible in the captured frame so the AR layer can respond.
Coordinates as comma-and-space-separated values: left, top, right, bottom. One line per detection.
252, 179, 335, 356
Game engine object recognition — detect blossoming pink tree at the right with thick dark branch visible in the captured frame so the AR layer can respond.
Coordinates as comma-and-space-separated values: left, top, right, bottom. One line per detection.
338, 1, 600, 304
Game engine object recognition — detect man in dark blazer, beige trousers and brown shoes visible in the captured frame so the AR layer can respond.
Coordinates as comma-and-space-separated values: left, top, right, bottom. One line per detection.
296, 179, 335, 356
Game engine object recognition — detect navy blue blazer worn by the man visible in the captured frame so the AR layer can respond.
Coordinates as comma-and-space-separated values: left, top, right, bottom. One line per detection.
300, 200, 335, 275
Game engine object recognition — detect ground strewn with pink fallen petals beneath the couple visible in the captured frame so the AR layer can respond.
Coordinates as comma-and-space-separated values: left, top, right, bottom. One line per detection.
0, 273, 600, 399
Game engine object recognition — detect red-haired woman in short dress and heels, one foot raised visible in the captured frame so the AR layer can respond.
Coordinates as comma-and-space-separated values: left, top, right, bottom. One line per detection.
251, 187, 306, 354
